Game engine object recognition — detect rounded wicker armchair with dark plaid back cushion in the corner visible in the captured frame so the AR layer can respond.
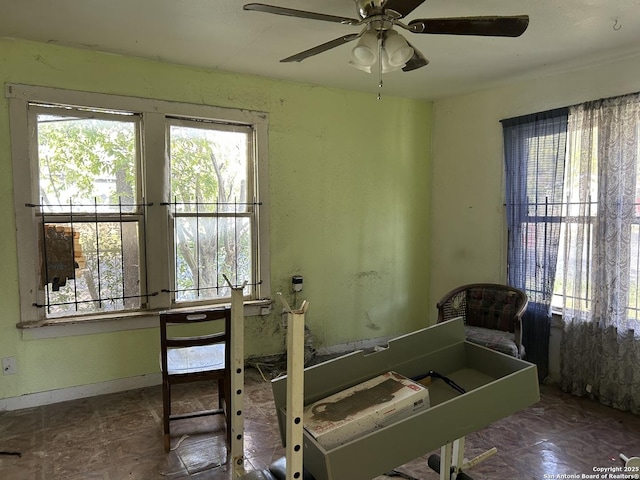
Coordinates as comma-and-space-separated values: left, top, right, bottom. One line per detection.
437, 283, 529, 358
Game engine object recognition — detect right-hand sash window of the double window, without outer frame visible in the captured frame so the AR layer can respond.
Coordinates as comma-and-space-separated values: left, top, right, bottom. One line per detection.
168, 120, 259, 302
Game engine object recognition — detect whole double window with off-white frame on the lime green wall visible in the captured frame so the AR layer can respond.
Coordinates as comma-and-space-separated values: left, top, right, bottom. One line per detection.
7, 85, 269, 323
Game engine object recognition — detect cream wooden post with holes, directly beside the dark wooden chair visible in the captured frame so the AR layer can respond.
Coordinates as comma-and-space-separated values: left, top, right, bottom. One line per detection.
225, 277, 247, 478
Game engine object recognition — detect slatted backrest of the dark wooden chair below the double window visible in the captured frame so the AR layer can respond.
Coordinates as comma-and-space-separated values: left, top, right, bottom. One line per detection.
160, 308, 231, 372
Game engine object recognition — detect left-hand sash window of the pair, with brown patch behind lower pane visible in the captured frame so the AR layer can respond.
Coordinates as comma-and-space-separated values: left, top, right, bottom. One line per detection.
33, 104, 145, 318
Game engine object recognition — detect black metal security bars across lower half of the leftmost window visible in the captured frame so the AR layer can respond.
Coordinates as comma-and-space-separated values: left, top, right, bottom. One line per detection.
26, 199, 156, 318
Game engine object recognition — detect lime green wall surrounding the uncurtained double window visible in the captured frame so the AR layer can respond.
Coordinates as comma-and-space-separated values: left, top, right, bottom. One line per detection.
0, 39, 433, 398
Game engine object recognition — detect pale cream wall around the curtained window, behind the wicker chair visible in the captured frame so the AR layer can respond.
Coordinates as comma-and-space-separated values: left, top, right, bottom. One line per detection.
429, 54, 640, 306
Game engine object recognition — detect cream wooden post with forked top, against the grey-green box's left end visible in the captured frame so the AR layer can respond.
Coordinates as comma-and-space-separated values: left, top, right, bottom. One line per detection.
279, 294, 309, 480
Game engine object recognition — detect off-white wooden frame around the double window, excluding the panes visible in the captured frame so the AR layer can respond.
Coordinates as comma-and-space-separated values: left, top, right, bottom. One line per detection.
5, 84, 271, 329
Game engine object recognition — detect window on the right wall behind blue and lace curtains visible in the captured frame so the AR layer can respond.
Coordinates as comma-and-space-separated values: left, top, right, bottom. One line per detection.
503, 95, 640, 328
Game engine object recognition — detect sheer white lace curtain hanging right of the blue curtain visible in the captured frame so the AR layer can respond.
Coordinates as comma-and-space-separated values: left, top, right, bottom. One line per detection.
556, 94, 640, 413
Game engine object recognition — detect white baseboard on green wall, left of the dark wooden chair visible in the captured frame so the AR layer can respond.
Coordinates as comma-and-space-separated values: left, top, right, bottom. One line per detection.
0, 373, 162, 411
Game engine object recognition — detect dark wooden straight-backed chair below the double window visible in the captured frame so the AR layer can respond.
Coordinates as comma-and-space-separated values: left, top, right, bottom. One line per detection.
160, 308, 231, 452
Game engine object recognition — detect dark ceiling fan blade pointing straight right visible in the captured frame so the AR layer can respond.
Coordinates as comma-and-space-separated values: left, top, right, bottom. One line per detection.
409, 15, 529, 37
